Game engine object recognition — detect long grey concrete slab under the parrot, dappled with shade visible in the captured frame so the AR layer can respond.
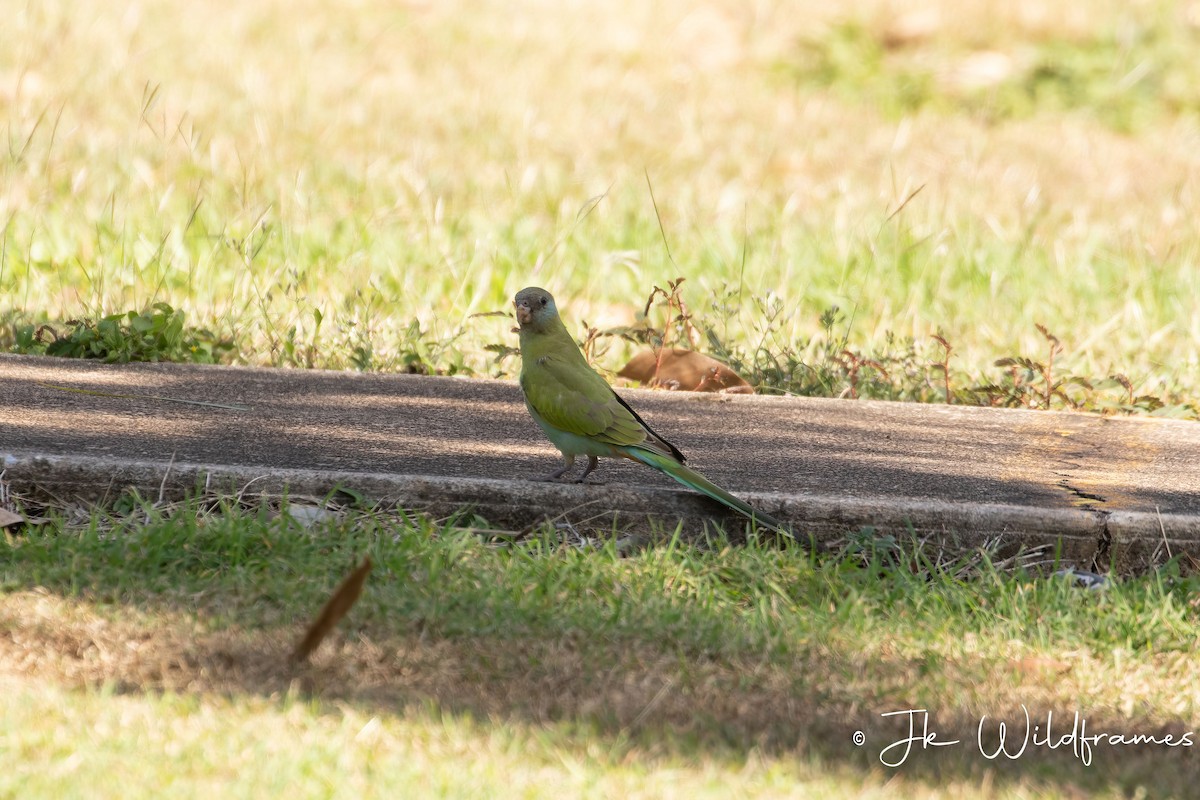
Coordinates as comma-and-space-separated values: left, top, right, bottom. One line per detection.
0, 356, 1200, 570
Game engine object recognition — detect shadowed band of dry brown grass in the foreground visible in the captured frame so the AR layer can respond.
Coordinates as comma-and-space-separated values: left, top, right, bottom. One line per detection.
0, 591, 1200, 796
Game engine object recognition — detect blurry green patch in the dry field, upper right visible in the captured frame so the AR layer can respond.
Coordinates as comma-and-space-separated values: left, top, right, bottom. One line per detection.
780, 13, 1200, 133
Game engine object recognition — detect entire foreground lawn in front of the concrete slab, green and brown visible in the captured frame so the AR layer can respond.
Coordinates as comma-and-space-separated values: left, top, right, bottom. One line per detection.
0, 501, 1200, 798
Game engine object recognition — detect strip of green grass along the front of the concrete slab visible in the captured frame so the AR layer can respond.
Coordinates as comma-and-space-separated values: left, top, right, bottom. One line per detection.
0, 504, 1198, 656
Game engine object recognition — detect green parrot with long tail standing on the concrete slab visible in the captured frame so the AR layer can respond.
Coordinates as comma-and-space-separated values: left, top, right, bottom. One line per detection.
514, 287, 792, 536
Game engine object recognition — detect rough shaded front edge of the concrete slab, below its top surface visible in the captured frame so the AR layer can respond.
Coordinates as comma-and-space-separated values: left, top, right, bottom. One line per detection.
9, 452, 1200, 572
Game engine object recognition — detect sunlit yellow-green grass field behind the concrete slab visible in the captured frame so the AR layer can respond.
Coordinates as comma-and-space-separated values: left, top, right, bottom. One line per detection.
0, 0, 1200, 415
